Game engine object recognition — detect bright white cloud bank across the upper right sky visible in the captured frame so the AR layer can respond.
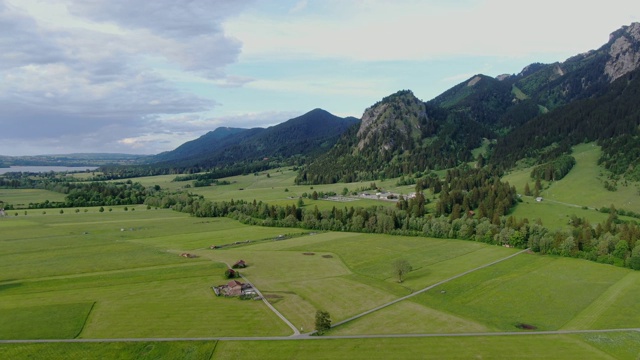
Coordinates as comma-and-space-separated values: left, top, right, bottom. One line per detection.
225, 0, 640, 61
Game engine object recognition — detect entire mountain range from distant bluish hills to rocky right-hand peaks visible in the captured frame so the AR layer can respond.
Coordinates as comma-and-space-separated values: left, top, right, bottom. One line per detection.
6, 23, 640, 184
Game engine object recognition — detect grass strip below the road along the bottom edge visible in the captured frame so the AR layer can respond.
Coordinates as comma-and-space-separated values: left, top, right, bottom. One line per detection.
0, 332, 640, 360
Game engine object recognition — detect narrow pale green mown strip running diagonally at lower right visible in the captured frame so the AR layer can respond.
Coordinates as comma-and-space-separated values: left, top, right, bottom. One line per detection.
562, 273, 637, 329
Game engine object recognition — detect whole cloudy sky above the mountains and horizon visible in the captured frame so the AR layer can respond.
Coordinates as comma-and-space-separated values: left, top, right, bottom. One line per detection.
0, 0, 640, 156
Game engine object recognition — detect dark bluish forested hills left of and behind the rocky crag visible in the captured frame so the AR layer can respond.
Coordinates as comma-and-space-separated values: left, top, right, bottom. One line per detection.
150, 109, 359, 169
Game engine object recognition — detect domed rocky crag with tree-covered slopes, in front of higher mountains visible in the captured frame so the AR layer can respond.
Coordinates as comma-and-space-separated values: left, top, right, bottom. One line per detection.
296, 90, 492, 184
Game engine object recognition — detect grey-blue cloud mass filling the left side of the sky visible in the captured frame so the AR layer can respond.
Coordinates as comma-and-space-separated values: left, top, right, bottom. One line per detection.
0, 0, 249, 155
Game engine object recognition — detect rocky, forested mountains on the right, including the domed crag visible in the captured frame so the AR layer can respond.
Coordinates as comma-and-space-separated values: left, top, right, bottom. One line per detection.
296, 23, 640, 183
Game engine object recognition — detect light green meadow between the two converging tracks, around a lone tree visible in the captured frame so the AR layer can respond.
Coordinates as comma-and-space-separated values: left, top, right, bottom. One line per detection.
198, 233, 514, 332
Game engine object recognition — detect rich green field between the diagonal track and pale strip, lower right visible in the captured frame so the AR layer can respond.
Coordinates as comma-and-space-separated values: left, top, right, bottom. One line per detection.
416, 254, 640, 331
